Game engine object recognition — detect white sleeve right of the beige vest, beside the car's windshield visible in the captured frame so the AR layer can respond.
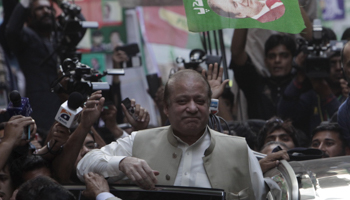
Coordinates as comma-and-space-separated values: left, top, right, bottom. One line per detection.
248, 147, 265, 199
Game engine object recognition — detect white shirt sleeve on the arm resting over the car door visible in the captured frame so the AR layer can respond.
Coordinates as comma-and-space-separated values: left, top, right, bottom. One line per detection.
77, 132, 137, 182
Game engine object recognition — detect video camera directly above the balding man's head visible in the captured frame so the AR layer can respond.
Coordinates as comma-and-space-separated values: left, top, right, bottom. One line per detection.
176, 49, 222, 70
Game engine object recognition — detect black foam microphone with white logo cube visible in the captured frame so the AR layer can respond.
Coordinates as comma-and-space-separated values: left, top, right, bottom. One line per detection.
55, 92, 85, 128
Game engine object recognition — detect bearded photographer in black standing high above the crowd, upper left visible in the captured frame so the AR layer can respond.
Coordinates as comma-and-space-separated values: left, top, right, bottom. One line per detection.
6, 0, 84, 133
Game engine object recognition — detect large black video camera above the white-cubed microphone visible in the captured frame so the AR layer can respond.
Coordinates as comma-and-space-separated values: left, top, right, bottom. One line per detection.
51, 58, 125, 105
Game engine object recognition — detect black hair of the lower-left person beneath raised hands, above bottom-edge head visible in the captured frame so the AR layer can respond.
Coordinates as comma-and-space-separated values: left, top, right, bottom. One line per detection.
10, 155, 51, 188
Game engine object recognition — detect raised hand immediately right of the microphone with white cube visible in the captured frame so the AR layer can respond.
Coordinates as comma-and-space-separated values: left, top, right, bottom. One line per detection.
80, 90, 105, 130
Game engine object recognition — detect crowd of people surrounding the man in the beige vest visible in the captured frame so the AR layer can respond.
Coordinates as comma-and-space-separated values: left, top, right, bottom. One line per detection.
0, 0, 350, 200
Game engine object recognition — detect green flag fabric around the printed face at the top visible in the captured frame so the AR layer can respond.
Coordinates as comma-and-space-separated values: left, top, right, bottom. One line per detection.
183, 0, 305, 34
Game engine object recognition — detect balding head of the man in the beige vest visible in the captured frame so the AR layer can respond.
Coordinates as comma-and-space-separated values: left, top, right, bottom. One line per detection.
164, 69, 212, 142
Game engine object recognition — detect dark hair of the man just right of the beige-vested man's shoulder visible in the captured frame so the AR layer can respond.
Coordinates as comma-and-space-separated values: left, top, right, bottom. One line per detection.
257, 117, 299, 151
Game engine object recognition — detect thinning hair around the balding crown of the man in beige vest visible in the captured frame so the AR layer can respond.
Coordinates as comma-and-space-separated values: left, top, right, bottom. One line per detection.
163, 69, 212, 106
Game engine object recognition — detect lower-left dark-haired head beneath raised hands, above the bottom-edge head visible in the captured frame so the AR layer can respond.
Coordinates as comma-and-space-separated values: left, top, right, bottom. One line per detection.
10, 155, 52, 188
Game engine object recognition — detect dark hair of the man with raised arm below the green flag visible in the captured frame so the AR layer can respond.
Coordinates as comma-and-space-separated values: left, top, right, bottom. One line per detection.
265, 34, 297, 56
